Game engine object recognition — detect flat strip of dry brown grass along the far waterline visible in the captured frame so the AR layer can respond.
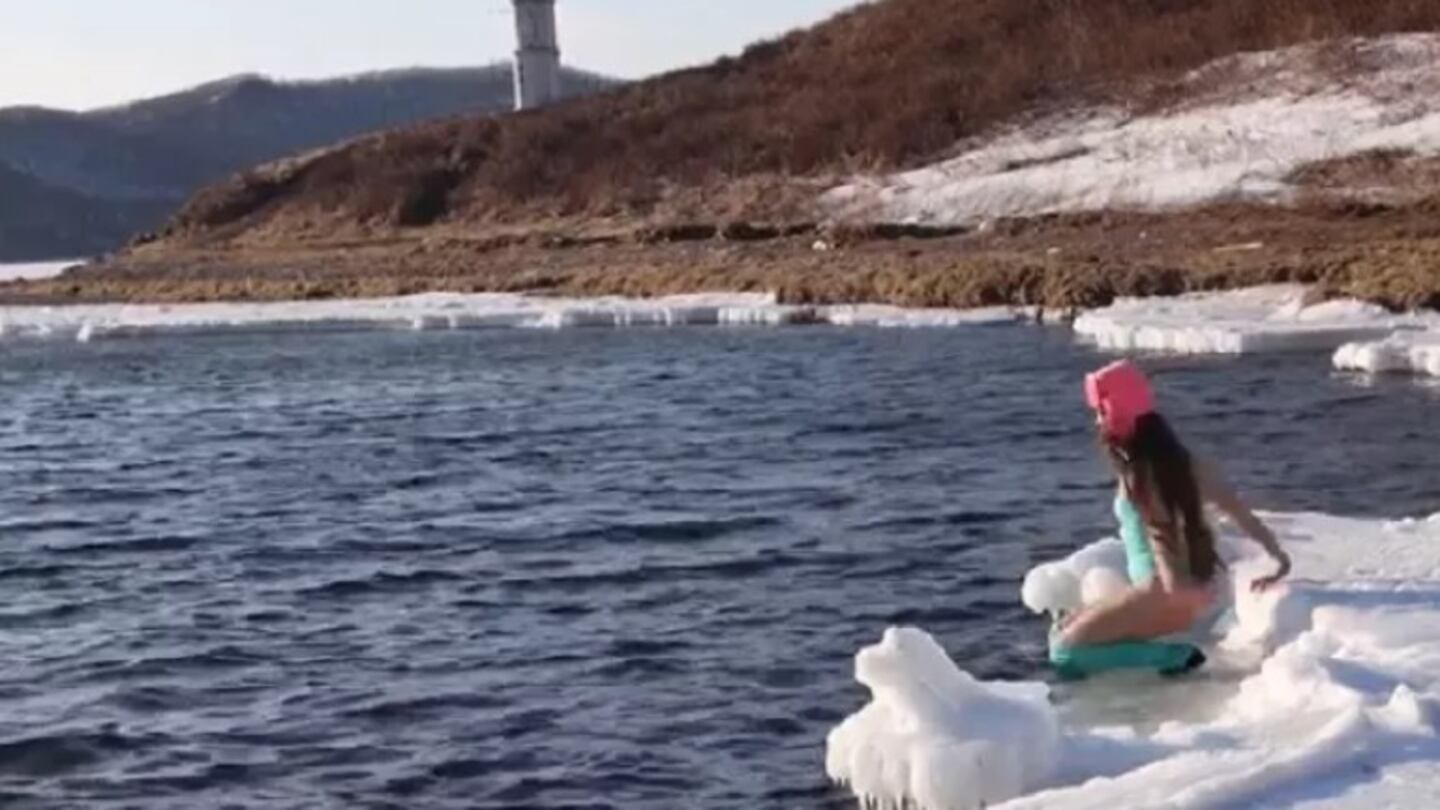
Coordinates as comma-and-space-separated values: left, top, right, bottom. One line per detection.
8, 199, 1440, 311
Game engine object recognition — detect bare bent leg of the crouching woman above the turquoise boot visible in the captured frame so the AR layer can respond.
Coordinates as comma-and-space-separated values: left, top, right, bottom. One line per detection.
1060, 588, 1210, 646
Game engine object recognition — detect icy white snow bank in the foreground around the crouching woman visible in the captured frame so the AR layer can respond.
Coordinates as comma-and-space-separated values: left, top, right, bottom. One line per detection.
827, 515, 1440, 810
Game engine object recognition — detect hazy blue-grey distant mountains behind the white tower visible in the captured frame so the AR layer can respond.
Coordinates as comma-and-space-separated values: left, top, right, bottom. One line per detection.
0, 65, 615, 261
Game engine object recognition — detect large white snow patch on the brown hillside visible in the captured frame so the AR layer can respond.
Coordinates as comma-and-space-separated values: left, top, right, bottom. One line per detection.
821, 33, 1440, 225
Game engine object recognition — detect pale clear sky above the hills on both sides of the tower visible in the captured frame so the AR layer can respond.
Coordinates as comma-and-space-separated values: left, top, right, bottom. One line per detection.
0, 0, 855, 110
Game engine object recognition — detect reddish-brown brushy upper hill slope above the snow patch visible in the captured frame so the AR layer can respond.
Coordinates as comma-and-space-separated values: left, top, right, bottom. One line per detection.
149, 0, 1440, 242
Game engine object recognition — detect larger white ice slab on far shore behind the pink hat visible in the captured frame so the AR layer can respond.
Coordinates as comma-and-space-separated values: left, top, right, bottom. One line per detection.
1074, 284, 1440, 355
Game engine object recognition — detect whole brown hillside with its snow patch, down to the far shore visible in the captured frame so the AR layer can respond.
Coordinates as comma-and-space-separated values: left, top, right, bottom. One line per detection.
7, 0, 1440, 307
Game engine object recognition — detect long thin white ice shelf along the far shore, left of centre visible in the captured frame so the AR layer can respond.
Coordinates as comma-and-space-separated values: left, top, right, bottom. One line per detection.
0, 293, 1017, 342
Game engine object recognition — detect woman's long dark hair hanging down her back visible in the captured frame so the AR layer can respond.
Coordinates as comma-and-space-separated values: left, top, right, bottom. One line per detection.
1103, 414, 1221, 582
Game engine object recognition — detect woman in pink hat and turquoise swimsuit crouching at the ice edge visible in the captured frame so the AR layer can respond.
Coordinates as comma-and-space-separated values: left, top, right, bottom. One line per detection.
1060, 360, 1290, 646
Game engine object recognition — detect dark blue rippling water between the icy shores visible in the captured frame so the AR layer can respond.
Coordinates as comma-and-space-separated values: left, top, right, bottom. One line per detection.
0, 327, 1440, 810
